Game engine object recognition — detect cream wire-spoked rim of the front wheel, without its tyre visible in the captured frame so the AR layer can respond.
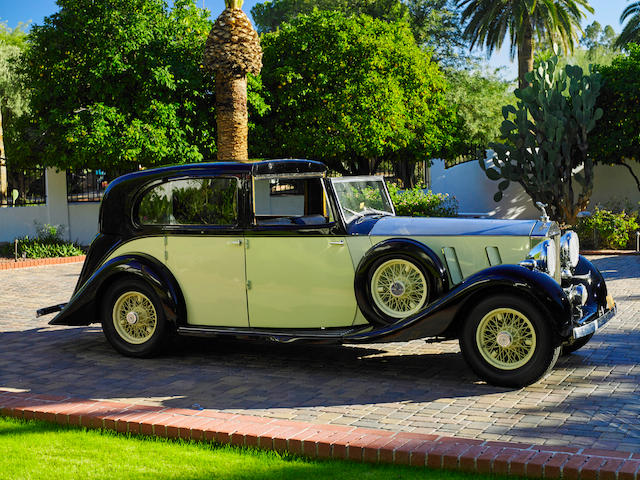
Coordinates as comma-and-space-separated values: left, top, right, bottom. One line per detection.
476, 308, 536, 370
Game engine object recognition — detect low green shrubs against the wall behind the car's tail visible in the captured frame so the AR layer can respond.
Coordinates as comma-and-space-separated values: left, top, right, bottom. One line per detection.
2, 225, 84, 258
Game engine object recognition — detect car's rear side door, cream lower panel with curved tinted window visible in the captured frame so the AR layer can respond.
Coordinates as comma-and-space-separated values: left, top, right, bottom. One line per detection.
140, 177, 249, 327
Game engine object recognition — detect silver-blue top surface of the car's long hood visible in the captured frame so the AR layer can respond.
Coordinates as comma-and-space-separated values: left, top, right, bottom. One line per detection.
369, 216, 554, 237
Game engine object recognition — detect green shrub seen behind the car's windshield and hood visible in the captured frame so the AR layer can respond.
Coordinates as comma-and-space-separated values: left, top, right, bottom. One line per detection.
389, 183, 458, 217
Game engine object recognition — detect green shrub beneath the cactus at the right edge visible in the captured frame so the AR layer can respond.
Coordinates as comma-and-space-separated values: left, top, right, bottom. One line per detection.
577, 207, 640, 250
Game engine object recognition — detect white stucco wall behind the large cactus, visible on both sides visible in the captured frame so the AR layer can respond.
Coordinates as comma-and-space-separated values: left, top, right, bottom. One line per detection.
430, 156, 640, 218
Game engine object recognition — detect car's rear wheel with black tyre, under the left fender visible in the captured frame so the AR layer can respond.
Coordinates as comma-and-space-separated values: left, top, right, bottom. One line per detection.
102, 279, 168, 357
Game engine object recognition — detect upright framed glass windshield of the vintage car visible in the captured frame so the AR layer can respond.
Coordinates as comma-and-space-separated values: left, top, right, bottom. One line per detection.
331, 177, 394, 223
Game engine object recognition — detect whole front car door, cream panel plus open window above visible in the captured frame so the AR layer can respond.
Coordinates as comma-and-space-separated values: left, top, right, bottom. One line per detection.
245, 179, 356, 329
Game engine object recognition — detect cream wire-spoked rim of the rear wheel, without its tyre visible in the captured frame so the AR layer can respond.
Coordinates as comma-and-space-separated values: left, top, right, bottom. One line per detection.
112, 292, 158, 345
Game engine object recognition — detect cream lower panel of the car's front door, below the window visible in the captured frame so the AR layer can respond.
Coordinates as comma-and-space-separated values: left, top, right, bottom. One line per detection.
245, 234, 356, 328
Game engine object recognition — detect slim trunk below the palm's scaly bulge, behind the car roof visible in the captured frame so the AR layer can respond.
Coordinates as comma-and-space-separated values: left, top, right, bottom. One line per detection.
216, 72, 249, 162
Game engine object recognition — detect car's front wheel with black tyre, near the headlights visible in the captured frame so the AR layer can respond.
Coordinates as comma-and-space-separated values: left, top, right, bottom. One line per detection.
460, 295, 561, 387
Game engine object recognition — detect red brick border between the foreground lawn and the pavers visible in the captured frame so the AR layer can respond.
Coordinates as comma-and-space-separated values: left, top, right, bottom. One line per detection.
0, 389, 640, 480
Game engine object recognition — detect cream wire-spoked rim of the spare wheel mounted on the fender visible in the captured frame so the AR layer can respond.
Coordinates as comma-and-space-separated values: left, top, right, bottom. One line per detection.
371, 259, 428, 318
